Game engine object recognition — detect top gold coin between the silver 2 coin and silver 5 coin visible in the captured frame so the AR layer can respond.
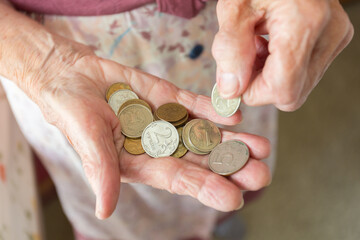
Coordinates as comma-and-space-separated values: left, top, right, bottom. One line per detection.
189, 119, 221, 152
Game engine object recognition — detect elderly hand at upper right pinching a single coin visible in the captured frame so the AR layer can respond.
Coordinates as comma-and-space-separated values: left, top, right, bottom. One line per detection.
212, 0, 354, 111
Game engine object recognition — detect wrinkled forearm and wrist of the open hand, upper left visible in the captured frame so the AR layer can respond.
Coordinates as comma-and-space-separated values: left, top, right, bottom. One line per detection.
0, 0, 93, 103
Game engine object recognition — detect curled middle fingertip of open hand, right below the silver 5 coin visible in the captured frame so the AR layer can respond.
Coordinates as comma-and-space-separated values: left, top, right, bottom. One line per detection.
229, 158, 271, 191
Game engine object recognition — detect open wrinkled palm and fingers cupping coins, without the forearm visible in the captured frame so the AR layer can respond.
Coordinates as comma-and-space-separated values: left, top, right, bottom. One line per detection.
31, 50, 271, 219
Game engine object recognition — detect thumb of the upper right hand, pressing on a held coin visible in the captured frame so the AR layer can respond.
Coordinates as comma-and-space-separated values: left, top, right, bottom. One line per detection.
212, 0, 259, 98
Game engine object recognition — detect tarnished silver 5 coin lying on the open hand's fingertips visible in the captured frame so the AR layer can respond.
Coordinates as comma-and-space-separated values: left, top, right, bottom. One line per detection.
208, 140, 249, 176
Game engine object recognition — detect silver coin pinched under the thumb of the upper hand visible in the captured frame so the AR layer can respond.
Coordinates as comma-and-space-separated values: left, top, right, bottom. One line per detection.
211, 83, 241, 117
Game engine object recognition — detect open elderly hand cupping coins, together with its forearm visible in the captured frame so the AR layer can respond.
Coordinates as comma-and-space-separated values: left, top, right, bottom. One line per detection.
0, 4, 271, 219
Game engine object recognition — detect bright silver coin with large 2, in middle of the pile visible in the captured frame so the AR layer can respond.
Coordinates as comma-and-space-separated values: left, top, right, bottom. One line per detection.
141, 120, 179, 158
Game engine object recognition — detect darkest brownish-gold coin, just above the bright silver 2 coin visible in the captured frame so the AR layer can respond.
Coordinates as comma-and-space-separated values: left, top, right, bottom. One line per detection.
155, 103, 187, 123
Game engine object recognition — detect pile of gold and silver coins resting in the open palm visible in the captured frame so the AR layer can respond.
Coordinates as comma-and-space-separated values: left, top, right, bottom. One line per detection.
106, 83, 249, 175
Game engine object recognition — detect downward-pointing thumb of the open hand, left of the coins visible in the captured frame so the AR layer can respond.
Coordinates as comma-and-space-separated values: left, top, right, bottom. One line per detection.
64, 101, 124, 219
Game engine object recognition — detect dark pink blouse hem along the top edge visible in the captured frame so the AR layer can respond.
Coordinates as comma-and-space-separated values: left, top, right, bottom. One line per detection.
10, 0, 207, 18
